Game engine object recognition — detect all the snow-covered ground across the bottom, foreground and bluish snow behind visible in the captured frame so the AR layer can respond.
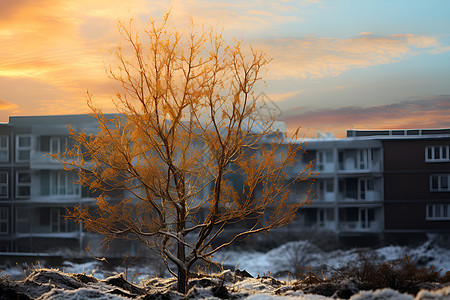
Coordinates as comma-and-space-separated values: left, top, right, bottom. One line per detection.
0, 241, 450, 300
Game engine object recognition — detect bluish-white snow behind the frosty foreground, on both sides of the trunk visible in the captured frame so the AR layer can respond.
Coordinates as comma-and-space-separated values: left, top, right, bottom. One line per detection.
4, 241, 450, 280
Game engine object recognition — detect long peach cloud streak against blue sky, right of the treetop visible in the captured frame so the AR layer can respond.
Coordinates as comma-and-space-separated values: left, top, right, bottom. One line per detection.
257, 33, 448, 79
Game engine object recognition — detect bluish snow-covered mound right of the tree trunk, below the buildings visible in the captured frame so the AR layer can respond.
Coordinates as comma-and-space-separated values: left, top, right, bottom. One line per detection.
214, 241, 450, 276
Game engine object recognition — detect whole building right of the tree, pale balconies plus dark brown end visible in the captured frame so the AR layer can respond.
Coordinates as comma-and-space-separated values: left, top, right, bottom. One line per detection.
290, 129, 450, 245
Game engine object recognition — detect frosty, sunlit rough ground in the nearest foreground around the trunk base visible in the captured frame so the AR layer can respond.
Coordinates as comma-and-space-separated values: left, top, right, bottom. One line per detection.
0, 269, 450, 300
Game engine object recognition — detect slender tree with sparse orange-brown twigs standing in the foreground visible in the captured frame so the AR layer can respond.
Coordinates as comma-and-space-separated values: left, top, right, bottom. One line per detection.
59, 17, 310, 293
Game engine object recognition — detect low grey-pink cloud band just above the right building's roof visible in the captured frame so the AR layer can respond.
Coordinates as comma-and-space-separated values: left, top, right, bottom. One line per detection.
283, 95, 450, 137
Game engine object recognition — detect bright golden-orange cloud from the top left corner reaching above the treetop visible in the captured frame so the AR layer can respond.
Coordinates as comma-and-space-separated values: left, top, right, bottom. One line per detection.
0, 0, 316, 119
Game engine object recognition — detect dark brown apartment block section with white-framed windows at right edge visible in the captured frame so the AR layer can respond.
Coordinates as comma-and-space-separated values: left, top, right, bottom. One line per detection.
383, 129, 450, 242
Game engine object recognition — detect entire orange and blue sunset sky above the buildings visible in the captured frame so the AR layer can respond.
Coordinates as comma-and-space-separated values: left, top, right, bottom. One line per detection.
0, 0, 450, 136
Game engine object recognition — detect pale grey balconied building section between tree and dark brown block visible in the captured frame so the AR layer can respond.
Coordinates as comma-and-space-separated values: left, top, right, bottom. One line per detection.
289, 136, 384, 246
